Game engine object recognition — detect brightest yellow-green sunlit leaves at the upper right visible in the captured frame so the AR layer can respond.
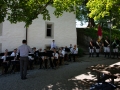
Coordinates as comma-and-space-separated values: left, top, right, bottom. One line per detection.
87, 0, 115, 20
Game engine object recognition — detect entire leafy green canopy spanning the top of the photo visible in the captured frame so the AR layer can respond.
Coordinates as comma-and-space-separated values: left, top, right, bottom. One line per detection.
0, 0, 120, 27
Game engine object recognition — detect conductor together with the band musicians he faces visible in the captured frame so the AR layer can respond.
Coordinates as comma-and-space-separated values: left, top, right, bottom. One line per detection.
1, 40, 78, 80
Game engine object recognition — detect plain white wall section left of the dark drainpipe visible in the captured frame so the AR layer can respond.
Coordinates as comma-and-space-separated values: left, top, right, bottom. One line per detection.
0, 21, 25, 52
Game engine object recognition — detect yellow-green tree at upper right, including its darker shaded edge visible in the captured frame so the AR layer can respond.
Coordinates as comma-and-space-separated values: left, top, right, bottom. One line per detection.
87, 0, 120, 27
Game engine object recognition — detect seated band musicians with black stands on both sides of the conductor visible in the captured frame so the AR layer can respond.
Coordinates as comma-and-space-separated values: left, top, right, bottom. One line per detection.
0, 44, 78, 74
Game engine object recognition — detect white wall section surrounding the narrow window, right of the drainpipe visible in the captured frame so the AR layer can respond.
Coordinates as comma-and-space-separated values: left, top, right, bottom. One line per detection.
28, 7, 77, 48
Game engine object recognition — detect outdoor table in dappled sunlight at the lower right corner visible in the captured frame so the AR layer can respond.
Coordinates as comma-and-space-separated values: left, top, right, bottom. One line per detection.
87, 64, 120, 84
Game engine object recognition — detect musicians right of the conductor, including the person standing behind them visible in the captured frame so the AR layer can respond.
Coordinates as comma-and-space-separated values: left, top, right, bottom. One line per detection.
30, 40, 78, 69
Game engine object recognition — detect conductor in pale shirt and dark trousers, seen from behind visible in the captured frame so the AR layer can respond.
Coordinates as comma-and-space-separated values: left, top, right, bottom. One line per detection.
17, 40, 32, 80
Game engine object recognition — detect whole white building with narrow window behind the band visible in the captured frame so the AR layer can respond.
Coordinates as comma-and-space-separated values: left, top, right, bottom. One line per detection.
0, 7, 77, 52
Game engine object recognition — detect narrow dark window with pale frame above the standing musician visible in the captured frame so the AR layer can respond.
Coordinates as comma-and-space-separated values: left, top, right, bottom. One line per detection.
46, 22, 53, 38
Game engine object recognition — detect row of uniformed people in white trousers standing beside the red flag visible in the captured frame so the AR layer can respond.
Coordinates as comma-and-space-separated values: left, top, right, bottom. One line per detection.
89, 36, 120, 58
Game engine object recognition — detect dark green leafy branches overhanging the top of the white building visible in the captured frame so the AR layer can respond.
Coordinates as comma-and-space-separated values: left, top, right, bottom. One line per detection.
0, 0, 83, 27
